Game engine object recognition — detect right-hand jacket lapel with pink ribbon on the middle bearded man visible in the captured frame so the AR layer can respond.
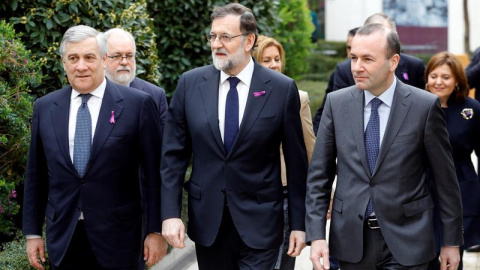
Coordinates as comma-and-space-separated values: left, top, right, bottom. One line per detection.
230, 62, 273, 154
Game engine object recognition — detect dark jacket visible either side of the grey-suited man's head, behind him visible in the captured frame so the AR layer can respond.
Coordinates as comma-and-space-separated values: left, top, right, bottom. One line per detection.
332, 53, 425, 91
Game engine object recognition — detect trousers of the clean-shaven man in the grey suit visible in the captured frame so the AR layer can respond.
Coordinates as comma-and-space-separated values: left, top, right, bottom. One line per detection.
340, 217, 428, 270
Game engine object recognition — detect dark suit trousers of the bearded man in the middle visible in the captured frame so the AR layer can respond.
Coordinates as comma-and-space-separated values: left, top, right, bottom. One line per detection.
195, 206, 278, 270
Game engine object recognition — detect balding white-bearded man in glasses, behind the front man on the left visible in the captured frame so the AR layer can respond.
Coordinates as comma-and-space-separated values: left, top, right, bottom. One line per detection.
105, 28, 168, 129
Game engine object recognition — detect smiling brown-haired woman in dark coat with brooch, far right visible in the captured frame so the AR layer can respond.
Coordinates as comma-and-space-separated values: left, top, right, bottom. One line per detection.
425, 52, 480, 269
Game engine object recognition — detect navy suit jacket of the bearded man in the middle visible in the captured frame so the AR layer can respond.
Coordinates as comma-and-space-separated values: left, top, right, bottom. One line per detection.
161, 62, 307, 249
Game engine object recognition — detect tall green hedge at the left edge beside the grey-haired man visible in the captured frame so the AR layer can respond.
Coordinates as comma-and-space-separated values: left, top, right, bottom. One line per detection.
0, 21, 42, 238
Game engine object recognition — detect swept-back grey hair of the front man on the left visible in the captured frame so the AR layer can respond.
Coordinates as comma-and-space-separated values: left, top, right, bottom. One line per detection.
59, 25, 107, 58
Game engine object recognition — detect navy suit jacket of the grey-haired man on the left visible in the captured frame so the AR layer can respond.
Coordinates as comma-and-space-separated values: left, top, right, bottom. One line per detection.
23, 80, 161, 268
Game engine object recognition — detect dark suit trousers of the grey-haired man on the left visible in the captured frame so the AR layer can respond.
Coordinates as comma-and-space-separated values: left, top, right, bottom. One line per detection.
50, 220, 138, 270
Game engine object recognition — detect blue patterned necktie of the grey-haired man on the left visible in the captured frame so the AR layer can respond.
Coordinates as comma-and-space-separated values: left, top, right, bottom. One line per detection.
73, 94, 92, 177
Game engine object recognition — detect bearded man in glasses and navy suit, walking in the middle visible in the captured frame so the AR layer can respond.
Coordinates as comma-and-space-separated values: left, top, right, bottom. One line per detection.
161, 4, 307, 270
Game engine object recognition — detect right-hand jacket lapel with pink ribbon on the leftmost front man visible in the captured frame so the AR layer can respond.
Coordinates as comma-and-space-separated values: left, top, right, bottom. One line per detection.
87, 80, 123, 165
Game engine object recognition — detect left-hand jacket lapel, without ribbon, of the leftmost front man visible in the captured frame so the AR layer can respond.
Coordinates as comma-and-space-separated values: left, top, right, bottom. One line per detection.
51, 87, 77, 172
